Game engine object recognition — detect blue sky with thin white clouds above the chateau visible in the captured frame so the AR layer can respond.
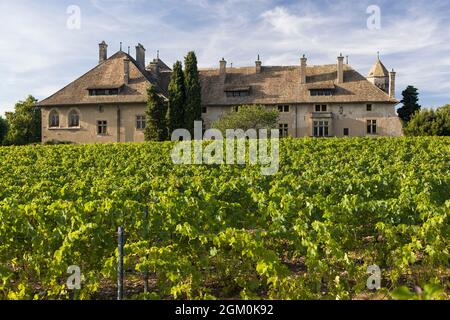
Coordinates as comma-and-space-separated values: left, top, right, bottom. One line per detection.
0, 0, 450, 115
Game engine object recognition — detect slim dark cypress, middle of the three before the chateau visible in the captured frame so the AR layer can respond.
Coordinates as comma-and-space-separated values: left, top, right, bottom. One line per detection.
167, 61, 186, 135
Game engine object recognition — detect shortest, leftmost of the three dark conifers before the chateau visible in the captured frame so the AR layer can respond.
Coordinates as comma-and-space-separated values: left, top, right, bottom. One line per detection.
144, 85, 167, 141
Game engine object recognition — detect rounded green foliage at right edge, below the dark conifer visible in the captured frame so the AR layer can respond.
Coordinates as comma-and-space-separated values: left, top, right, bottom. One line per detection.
403, 104, 450, 136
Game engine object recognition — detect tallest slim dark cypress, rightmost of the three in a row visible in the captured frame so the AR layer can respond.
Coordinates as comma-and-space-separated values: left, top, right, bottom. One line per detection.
184, 51, 202, 135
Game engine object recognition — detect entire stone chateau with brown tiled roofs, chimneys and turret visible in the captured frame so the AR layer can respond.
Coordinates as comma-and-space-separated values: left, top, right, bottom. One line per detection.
39, 42, 402, 143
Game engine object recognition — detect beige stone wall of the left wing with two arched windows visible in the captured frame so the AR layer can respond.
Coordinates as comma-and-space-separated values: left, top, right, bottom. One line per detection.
42, 104, 145, 143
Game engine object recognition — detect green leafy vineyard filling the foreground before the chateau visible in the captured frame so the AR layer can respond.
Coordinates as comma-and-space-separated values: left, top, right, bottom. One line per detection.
0, 138, 450, 299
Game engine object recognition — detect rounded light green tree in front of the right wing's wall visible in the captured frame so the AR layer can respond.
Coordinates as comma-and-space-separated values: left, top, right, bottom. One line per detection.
212, 105, 279, 133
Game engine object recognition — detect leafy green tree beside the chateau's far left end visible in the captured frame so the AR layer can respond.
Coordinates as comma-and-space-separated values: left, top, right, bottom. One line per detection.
5, 95, 41, 145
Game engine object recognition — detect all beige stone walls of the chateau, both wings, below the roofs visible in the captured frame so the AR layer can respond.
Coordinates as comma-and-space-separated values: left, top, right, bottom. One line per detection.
42, 104, 402, 143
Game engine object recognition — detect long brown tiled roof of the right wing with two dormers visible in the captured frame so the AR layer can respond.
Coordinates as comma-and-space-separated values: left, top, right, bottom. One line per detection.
200, 64, 398, 105
